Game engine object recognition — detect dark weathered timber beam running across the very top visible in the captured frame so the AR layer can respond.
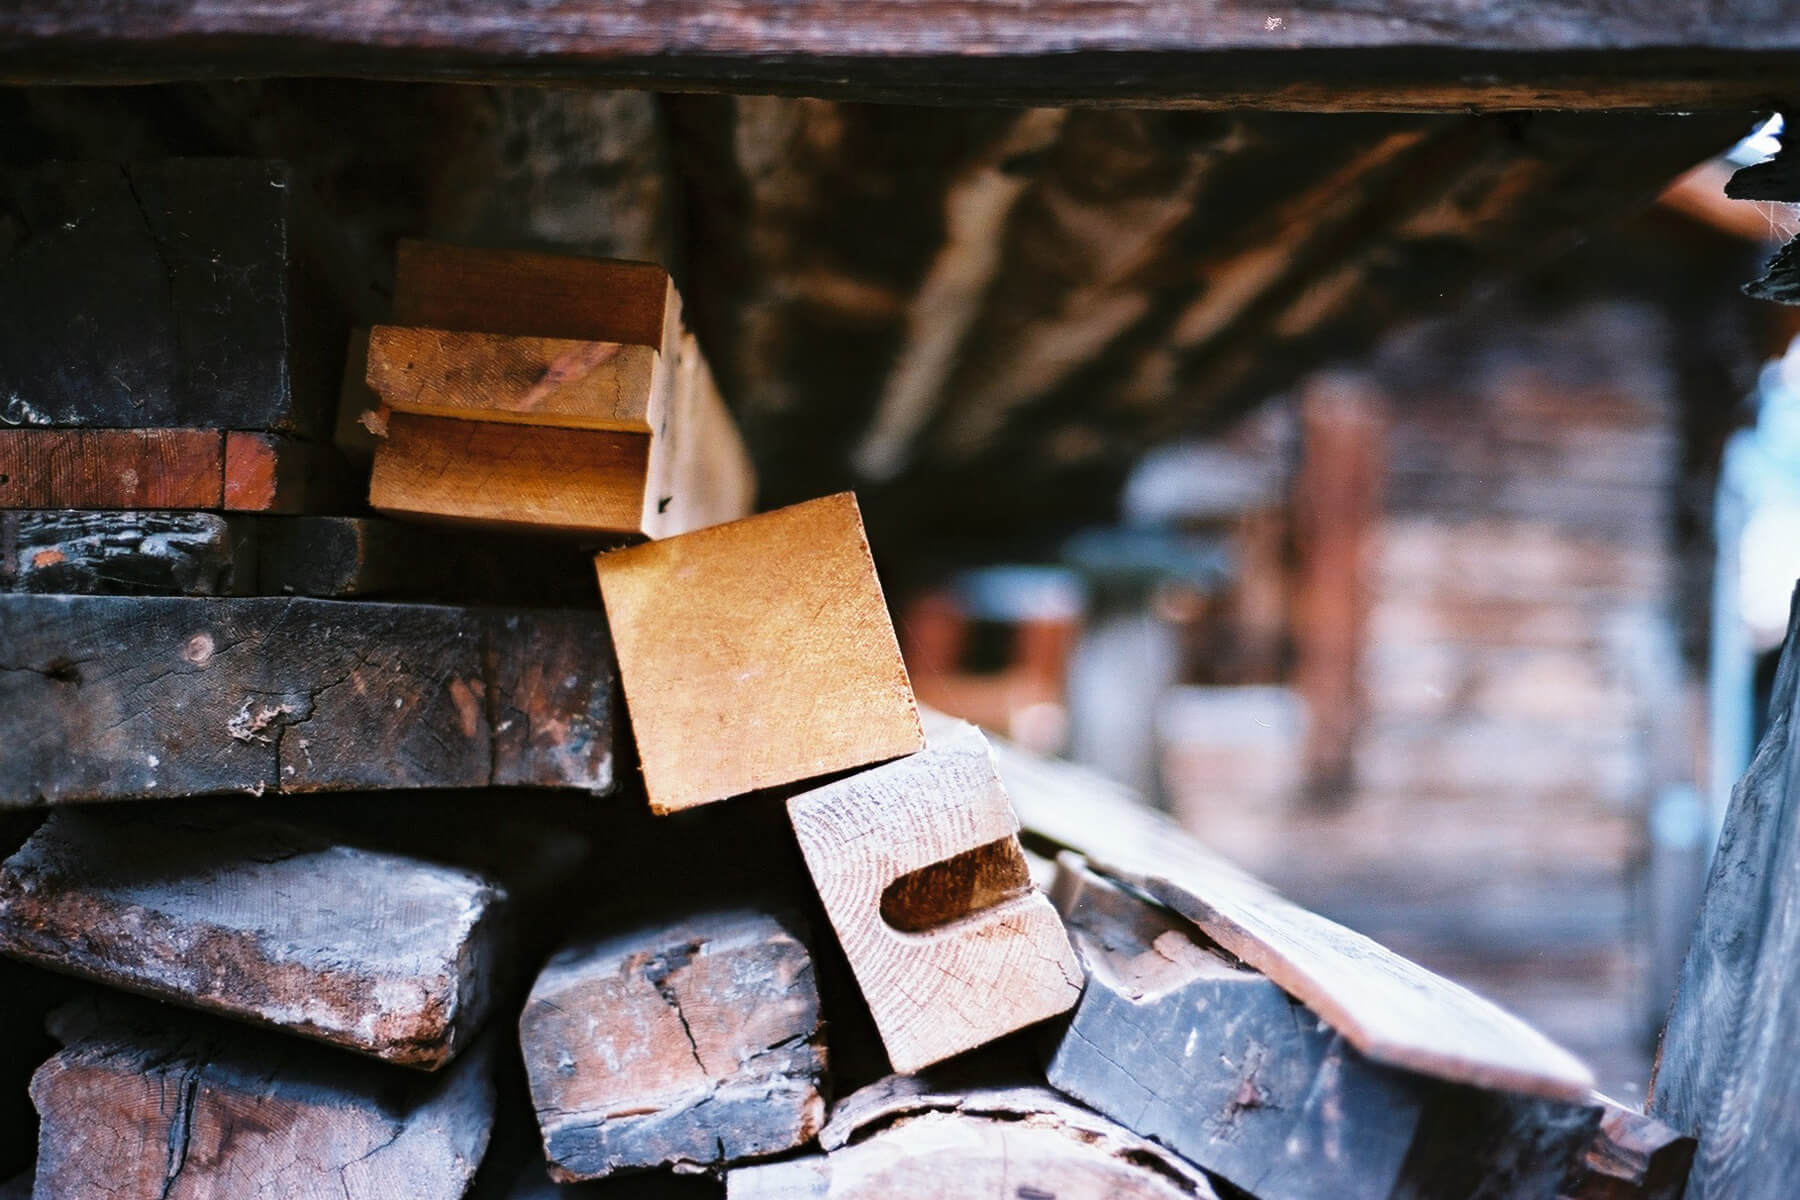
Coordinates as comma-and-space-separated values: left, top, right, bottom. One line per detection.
0, 0, 1800, 112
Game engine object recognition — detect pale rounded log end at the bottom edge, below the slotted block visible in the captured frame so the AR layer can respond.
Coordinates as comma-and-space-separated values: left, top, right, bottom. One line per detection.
725, 1076, 1217, 1200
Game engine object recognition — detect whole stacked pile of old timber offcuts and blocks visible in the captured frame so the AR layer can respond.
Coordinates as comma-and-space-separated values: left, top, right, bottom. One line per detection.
0, 162, 1694, 1200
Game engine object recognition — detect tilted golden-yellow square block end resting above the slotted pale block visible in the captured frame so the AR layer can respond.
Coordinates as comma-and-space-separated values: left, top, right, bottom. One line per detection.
594, 493, 923, 813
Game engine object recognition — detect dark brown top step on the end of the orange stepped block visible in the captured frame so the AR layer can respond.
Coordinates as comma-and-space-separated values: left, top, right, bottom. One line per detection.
394, 237, 680, 351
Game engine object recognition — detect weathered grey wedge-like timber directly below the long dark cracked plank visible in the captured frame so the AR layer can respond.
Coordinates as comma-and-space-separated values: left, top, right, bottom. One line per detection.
0, 810, 508, 1069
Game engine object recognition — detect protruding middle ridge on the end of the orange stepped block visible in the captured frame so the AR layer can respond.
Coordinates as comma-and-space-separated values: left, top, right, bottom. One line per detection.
367, 326, 659, 434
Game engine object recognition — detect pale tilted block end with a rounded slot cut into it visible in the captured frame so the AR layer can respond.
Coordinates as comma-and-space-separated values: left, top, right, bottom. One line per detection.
788, 727, 1082, 1070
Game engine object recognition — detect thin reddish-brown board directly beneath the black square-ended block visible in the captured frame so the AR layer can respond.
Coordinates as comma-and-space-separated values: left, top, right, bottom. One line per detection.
0, 430, 225, 509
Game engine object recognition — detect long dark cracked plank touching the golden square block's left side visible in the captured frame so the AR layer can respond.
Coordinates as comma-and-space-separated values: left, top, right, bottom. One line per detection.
0, 596, 616, 804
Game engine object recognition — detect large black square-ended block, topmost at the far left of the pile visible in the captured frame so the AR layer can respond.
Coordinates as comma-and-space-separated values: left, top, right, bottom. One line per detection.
0, 158, 338, 434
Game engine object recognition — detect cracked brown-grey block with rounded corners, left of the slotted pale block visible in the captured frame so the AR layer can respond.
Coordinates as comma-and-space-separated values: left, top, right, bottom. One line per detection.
518, 909, 824, 1180
